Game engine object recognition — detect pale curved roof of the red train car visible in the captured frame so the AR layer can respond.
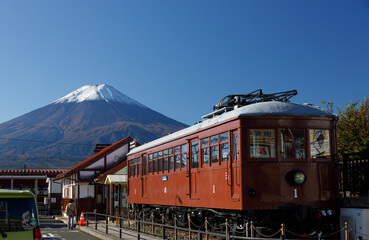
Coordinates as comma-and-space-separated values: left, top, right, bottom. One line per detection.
128, 101, 336, 155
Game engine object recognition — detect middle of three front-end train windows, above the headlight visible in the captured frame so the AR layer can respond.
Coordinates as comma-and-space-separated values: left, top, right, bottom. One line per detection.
281, 128, 305, 159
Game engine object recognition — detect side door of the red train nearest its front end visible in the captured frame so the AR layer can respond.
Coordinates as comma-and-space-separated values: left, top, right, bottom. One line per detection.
230, 131, 241, 201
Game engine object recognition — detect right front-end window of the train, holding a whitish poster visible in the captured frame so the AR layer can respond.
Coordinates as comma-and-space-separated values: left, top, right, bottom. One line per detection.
309, 129, 331, 158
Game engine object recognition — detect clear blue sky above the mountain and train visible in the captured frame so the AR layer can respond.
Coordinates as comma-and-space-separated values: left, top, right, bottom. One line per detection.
0, 0, 369, 124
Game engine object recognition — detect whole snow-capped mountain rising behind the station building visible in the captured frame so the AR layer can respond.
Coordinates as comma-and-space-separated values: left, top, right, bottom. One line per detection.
0, 84, 186, 169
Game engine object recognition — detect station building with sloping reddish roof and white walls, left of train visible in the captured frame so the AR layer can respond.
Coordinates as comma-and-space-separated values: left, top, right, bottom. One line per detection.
55, 137, 135, 216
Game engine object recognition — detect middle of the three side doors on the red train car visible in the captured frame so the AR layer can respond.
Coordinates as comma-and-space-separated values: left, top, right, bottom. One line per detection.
188, 139, 200, 199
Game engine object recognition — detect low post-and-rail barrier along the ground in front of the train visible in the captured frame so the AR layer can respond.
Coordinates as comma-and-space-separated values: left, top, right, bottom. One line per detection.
85, 212, 360, 240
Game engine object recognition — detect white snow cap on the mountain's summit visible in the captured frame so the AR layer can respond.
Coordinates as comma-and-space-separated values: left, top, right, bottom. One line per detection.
53, 84, 145, 107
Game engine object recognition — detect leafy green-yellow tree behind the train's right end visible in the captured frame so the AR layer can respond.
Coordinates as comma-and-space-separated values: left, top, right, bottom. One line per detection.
334, 95, 369, 154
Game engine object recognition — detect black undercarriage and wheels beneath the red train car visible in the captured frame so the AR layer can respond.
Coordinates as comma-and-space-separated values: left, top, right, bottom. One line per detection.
131, 204, 339, 238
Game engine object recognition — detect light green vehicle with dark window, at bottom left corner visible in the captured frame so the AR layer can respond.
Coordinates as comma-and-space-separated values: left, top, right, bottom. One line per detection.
0, 189, 42, 240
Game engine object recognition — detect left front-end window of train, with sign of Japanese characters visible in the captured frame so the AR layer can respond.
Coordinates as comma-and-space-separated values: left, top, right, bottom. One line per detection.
250, 129, 275, 158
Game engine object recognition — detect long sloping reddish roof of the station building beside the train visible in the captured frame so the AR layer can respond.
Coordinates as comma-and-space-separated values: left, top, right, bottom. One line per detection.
55, 137, 132, 180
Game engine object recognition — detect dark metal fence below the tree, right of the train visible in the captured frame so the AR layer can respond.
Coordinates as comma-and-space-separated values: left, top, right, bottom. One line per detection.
339, 153, 369, 197
